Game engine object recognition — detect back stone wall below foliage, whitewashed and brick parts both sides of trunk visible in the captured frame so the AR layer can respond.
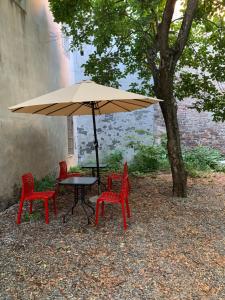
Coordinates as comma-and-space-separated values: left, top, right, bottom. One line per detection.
76, 95, 225, 163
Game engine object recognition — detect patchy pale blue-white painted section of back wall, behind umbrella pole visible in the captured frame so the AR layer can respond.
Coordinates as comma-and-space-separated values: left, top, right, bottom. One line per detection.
73, 46, 155, 163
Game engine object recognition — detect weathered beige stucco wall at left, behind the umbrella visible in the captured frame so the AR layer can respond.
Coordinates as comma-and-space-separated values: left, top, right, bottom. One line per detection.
0, 0, 69, 210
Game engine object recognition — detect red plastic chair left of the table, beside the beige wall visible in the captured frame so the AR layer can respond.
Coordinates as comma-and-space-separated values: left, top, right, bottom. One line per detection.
17, 173, 57, 224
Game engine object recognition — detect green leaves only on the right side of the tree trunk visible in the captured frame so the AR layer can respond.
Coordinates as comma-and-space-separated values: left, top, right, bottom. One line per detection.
176, 1, 225, 121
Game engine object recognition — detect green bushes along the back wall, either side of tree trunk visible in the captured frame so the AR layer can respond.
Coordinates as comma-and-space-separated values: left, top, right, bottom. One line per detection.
128, 136, 225, 177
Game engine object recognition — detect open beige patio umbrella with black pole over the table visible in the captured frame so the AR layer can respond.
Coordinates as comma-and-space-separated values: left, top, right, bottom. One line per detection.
9, 80, 160, 192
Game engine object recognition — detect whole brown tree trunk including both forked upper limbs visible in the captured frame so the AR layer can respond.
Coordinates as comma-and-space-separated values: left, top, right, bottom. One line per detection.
147, 0, 198, 197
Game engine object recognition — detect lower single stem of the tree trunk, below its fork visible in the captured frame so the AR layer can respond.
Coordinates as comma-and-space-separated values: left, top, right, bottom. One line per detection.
157, 72, 187, 197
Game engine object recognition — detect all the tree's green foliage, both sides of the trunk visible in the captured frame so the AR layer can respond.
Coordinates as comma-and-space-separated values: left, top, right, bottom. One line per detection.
50, 0, 225, 120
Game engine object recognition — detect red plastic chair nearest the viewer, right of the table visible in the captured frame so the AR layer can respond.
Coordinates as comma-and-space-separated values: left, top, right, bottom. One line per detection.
95, 175, 130, 230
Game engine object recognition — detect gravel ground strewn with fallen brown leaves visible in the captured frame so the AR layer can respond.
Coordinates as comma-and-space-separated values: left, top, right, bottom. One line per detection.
0, 174, 225, 300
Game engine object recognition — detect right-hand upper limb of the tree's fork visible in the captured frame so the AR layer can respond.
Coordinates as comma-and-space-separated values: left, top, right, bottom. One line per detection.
173, 0, 198, 64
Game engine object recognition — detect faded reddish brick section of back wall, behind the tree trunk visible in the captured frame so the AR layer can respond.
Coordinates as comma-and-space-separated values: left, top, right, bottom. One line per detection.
155, 99, 225, 153
